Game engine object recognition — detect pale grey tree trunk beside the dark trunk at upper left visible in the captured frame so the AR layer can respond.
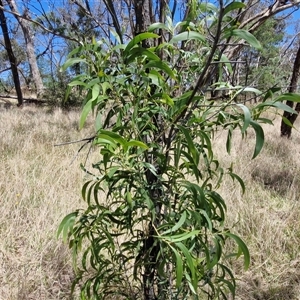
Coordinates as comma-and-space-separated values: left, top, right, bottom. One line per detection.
7, 0, 44, 96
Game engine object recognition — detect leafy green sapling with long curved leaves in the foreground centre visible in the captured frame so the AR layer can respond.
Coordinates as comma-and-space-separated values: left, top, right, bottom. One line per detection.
58, 4, 298, 299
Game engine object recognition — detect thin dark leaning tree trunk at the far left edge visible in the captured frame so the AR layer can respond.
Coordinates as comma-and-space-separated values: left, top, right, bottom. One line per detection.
0, 0, 23, 106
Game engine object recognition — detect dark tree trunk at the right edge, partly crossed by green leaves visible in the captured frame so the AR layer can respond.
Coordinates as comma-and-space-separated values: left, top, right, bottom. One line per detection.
280, 46, 300, 138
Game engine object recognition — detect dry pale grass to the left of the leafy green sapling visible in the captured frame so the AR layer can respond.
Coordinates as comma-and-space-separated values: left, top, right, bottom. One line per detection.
0, 108, 95, 300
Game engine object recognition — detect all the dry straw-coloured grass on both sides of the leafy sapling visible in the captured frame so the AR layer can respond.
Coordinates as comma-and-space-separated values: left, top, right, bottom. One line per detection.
0, 108, 300, 300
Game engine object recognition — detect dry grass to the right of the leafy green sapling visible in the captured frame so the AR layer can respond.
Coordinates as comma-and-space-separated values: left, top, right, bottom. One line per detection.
215, 114, 300, 300
